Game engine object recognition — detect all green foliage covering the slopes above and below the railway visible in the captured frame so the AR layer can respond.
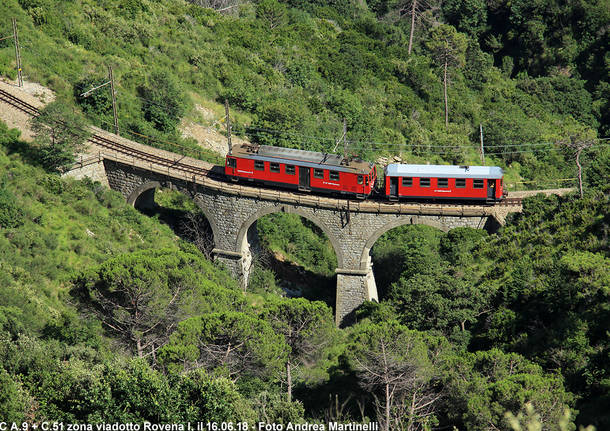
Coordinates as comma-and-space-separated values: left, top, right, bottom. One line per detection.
0, 0, 610, 431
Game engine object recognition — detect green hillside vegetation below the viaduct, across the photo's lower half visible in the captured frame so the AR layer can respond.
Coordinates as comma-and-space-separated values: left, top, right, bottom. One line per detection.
0, 116, 610, 430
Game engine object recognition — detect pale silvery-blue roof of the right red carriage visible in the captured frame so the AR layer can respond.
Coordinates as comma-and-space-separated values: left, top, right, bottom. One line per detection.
385, 163, 503, 179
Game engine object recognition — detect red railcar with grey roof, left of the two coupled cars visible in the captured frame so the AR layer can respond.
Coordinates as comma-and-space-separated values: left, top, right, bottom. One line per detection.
225, 144, 377, 199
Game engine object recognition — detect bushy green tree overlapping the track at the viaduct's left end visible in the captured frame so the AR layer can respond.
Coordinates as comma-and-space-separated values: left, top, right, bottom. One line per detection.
30, 100, 90, 172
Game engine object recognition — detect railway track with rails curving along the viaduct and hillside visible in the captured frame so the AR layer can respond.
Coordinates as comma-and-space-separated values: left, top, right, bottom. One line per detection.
0, 88, 522, 212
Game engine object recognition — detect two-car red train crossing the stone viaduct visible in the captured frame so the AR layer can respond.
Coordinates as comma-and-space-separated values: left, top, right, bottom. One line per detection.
225, 144, 505, 203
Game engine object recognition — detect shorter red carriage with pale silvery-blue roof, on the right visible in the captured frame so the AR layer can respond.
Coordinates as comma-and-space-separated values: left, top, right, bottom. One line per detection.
384, 164, 504, 203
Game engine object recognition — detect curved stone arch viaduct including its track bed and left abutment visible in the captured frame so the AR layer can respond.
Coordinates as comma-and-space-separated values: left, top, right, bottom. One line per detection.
0, 82, 521, 325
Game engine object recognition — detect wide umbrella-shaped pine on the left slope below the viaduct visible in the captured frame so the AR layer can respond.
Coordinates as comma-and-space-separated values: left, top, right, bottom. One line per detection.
74, 249, 242, 357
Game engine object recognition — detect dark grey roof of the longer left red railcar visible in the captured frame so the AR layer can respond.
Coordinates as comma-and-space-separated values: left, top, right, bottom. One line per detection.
231, 144, 373, 175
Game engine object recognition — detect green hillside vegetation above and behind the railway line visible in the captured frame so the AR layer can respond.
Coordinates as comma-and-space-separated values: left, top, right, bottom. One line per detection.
0, 0, 610, 188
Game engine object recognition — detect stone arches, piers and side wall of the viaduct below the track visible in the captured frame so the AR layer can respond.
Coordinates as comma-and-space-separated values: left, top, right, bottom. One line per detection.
103, 157, 502, 325
